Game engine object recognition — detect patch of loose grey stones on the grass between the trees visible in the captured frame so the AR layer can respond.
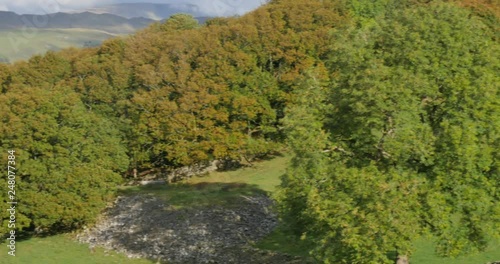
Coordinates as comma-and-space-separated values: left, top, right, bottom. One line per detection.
77, 194, 300, 264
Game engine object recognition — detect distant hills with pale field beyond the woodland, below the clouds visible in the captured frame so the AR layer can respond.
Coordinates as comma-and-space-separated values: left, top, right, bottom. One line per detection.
0, 9, 208, 62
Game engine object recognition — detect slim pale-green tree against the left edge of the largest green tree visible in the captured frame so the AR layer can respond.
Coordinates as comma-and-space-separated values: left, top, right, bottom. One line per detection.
277, 70, 328, 236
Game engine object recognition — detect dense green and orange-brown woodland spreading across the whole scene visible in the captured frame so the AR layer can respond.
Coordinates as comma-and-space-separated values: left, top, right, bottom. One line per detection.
0, 0, 500, 263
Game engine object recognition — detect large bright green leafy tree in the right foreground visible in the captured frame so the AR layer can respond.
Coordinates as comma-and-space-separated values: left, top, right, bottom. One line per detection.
279, 3, 500, 263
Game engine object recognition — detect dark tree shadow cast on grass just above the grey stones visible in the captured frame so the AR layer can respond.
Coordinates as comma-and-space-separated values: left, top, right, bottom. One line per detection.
118, 182, 267, 208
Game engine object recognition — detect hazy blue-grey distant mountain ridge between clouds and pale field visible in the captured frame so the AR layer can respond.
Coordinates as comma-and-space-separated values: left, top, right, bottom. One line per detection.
0, 11, 155, 34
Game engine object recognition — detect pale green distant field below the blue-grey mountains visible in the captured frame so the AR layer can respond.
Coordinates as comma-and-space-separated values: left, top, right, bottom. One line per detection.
0, 29, 114, 62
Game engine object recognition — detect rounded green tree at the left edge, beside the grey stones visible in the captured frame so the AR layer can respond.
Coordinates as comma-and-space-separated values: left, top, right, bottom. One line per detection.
0, 86, 128, 234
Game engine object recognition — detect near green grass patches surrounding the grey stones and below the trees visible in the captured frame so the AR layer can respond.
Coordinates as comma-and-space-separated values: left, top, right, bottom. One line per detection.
0, 156, 500, 264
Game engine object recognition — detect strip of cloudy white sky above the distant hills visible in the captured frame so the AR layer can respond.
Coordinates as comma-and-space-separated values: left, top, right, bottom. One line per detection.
0, 0, 265, 16
